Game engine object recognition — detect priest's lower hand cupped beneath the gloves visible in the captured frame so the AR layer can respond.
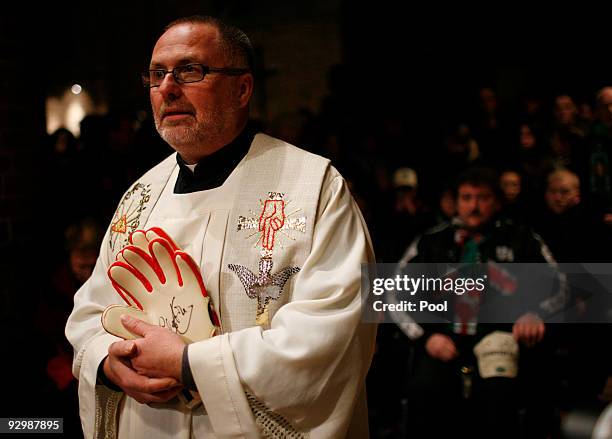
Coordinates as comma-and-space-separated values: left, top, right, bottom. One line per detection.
103, 341, 182, 404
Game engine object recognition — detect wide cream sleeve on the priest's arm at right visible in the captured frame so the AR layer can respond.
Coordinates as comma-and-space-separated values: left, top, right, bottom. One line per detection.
189, 170, 376, 437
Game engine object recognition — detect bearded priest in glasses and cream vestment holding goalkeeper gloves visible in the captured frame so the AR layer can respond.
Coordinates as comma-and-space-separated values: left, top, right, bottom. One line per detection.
66, 16, 375, 438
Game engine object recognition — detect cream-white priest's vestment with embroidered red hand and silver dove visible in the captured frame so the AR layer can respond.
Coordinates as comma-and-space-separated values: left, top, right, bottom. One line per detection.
66, 134, 376, 439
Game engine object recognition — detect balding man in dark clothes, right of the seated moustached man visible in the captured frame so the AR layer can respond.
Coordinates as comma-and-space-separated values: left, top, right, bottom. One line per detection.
534, 168, 612, 416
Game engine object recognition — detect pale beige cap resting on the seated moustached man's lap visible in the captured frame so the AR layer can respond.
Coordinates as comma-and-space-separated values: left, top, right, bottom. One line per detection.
474, 331, 519, 378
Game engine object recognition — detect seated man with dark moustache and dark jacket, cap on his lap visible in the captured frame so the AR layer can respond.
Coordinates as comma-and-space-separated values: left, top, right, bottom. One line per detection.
402, 168, 554, 438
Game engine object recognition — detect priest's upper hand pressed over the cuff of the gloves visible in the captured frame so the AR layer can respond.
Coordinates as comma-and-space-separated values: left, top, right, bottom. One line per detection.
121, 315, 185, 381
